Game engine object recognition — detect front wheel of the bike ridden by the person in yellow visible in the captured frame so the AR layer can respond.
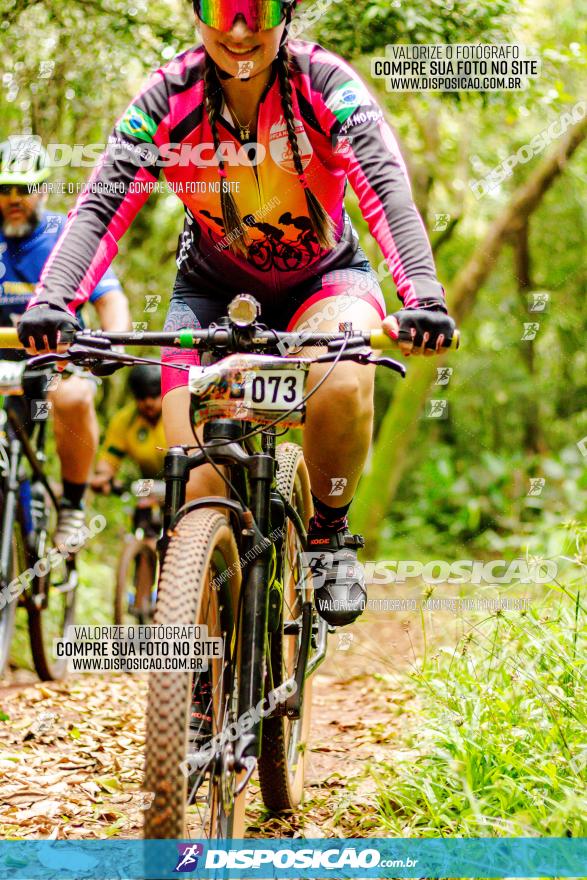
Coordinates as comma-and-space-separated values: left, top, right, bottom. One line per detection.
114, 536, 157, 625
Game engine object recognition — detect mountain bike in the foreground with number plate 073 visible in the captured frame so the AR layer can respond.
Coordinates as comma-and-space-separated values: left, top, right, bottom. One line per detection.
0, 294, 457, 840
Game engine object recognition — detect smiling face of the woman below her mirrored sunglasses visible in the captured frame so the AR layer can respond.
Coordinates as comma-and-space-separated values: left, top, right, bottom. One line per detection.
196, 15, 285, 79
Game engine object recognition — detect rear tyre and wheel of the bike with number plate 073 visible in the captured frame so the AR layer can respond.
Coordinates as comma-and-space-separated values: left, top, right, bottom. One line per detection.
259, 443, 312, 812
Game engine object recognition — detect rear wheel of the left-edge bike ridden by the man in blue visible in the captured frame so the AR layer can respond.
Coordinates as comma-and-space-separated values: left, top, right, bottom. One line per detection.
27, 482, 78, 681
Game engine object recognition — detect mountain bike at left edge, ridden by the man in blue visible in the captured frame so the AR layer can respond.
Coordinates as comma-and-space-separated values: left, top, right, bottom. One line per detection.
0, 361, 78, 681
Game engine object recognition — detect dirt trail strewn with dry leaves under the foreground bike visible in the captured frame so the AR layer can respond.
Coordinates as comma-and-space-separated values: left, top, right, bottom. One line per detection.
0, 600, 420, 839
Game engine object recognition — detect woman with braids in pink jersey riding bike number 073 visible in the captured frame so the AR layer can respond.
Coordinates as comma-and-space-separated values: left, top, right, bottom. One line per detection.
19, 0, 454, 625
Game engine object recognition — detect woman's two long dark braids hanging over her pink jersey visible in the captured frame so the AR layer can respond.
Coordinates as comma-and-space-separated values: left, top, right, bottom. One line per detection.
204, 35, 336, 259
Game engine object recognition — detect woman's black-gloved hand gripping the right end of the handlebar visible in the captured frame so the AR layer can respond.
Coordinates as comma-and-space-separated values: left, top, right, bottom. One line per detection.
383, 309, 456, 357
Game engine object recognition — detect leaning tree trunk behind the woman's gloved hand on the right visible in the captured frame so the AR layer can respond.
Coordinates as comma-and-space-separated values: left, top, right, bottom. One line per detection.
351, 118, 587, 558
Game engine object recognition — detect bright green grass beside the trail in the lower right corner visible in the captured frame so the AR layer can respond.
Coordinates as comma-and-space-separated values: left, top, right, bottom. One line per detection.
372, 588, 587, 837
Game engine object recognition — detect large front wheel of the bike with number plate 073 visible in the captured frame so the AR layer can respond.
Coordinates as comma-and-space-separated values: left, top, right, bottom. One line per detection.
144, 508, 246, 840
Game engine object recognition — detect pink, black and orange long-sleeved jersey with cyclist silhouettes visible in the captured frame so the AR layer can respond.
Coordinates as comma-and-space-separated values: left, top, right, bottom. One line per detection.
30, 40, 444, 311
